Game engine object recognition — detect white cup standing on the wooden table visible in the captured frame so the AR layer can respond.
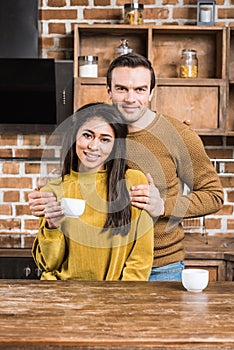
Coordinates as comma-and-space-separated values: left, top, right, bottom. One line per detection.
182, 269, 209, 292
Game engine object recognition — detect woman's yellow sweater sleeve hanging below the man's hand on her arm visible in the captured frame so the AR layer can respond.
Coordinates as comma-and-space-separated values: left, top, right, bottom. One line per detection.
121, 210, 154, 281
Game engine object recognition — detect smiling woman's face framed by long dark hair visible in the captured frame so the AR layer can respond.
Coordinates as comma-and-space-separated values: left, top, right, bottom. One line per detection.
76, 117, 115, 172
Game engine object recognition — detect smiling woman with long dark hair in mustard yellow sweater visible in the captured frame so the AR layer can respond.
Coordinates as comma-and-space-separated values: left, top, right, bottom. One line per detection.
32, 103, 153, 280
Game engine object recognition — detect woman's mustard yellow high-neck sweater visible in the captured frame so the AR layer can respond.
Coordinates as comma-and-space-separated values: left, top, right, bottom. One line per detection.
32, 170, 153, 280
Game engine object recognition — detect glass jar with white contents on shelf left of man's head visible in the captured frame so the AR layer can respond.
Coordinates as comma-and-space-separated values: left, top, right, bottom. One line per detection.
78, 56, 98, 78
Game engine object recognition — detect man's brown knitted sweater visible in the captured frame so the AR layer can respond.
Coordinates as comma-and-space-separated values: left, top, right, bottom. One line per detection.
127, 115, 223, 267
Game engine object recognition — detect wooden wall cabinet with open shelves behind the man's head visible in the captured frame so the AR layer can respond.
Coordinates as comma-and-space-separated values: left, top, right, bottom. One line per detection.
74, 24, 227, 135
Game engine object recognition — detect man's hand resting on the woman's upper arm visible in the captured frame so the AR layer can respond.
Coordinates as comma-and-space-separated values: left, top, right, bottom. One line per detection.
130, 174, 164, 218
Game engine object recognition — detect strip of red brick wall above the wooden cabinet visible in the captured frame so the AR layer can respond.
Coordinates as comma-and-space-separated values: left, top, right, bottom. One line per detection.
39, 0, 234, 59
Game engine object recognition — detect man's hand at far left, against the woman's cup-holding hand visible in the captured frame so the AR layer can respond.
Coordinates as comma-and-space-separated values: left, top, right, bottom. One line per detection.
28, 190, 57, 217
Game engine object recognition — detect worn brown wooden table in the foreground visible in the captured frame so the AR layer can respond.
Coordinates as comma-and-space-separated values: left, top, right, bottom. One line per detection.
0, 280, 234, 350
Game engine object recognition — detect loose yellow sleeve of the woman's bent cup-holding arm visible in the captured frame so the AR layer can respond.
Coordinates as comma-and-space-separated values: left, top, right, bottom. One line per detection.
32, 218, 66, 272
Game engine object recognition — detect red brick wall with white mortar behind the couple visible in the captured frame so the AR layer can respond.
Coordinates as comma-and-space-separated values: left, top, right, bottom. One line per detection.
0, 0, 234, 248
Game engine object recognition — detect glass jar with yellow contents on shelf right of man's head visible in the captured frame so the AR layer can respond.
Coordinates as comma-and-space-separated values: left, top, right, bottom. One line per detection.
180, 49, 198, 78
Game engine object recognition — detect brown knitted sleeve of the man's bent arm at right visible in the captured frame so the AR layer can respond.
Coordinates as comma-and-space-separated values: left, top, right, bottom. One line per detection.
164, 128, 223, 218
